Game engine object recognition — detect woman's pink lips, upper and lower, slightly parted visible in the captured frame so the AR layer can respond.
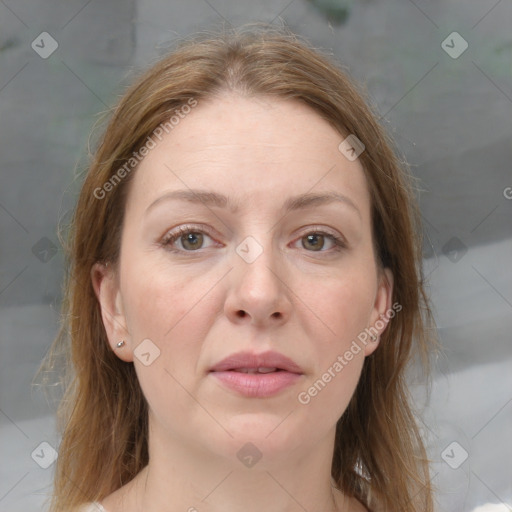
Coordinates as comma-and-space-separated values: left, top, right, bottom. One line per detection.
209, 352, 303, 398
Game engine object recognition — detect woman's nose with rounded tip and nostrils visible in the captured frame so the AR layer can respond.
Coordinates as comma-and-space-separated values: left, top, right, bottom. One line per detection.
225, 237, 293, 327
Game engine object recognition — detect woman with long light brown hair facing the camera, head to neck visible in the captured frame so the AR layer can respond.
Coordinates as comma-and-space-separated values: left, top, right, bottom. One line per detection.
39, 23, 433, 512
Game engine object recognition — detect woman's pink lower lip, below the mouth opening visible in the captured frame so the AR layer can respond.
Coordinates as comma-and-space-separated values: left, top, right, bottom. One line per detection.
211, 371, 301, 398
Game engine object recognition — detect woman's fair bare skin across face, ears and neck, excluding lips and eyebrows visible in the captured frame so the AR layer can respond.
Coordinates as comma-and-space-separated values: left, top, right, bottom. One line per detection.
91, 93, 393, 512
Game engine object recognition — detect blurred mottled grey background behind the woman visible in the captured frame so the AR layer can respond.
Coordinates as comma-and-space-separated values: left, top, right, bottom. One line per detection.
0, 0, 512, 512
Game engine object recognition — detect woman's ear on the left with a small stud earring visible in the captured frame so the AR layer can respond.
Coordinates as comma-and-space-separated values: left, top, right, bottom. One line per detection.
91, 263, 133, 362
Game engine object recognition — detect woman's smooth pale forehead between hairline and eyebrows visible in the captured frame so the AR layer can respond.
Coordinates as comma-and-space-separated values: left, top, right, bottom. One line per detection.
129, 94, 369, 220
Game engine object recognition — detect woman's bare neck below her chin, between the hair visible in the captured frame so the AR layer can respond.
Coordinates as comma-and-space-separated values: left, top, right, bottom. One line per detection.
122, 416, 345, 512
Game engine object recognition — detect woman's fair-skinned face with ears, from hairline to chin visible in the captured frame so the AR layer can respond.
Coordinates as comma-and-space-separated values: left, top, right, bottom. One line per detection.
93, 94, 392, 460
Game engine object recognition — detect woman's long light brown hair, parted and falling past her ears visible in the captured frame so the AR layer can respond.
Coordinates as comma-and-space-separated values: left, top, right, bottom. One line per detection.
36, 22, 435, 512
